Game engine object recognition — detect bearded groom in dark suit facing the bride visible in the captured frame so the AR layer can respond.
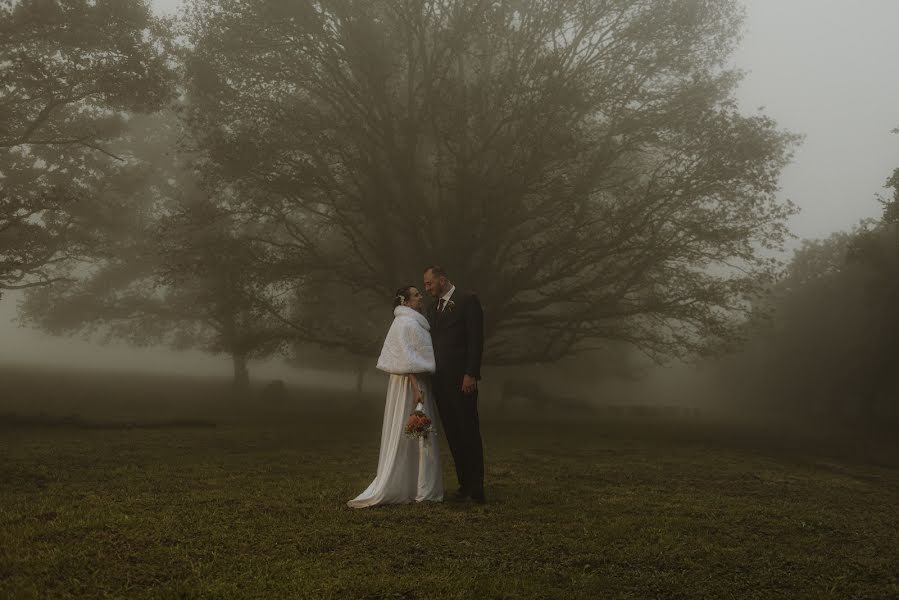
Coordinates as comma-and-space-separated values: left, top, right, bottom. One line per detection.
424, 266, 486, 504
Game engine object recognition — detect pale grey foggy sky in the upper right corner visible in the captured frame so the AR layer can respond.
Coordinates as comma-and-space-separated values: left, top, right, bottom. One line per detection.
735, 0, 899, 240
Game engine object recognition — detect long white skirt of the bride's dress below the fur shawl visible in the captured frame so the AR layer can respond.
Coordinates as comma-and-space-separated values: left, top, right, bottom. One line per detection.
347, 374, 443, 508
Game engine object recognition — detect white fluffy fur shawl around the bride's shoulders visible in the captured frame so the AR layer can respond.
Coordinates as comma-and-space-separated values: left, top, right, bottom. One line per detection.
378, 306, 436, 375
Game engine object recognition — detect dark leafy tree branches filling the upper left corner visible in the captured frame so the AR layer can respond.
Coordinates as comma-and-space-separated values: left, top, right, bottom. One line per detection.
0, 0, 173, 294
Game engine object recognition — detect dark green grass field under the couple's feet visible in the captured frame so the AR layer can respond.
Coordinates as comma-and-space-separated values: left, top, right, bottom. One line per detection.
0, 364, 899, 599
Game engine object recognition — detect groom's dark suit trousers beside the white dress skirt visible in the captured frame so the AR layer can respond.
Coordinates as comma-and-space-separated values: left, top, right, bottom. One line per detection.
434, 375, 484, 495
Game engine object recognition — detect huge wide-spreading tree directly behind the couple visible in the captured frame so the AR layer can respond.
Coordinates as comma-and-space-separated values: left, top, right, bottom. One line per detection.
185, 0, 796, 364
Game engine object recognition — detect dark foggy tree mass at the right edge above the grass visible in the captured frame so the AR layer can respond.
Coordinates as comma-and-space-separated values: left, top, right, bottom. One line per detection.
719, 211, 899, 418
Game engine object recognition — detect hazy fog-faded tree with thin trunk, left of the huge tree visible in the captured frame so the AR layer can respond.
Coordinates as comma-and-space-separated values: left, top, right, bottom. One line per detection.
21, 113, 285, 389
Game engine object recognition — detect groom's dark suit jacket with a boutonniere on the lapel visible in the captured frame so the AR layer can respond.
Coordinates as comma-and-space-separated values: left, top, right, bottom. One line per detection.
427, 288, 484, 386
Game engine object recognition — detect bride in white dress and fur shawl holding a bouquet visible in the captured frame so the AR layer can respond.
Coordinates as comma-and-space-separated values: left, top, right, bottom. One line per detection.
347, 285, 443, 508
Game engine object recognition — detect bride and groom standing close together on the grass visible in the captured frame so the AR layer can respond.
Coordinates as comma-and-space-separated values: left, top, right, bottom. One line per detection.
347, 266, 485, 508
